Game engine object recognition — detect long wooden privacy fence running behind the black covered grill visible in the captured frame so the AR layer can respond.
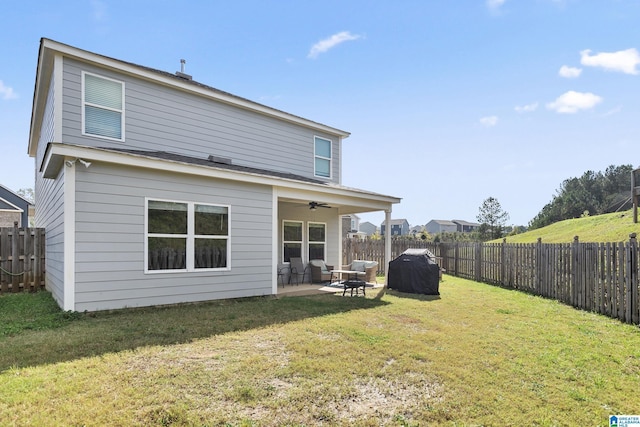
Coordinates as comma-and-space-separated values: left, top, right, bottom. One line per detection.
343, 233, 640, 325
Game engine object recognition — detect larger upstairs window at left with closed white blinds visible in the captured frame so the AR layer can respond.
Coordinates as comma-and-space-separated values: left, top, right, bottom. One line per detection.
82, 72, 124, 141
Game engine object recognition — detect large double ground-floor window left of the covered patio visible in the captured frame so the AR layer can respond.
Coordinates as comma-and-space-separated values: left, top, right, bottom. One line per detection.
145, 199, 230, 272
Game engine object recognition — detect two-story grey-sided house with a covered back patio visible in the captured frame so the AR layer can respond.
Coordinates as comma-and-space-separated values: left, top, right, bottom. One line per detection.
28, 39, 400, 311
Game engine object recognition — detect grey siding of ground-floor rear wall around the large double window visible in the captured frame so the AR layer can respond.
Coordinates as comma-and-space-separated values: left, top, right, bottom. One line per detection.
72, 162, 274, 311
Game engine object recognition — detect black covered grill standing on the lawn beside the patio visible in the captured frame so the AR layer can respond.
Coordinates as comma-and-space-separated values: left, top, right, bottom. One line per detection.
388, 249, 440, 295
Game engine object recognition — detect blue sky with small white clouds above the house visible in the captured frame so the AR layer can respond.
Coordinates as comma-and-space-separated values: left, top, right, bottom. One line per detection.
0, 0, 640, 225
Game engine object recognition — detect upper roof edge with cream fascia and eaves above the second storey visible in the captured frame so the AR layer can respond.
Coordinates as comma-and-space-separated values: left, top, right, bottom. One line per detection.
28, 38, 350, 156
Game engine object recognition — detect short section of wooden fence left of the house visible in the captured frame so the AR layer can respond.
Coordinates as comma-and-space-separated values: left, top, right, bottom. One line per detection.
0, 223, 45, 293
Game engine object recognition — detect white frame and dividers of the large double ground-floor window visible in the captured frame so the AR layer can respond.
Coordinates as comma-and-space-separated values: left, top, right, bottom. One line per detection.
144, 197, 231, 274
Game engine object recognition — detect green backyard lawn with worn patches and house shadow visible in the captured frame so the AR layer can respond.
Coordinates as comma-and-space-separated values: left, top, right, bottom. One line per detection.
0, 276, 640, 426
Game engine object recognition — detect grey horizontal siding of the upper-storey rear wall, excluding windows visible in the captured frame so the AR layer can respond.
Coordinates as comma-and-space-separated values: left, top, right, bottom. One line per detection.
67, 58, 341, 183
